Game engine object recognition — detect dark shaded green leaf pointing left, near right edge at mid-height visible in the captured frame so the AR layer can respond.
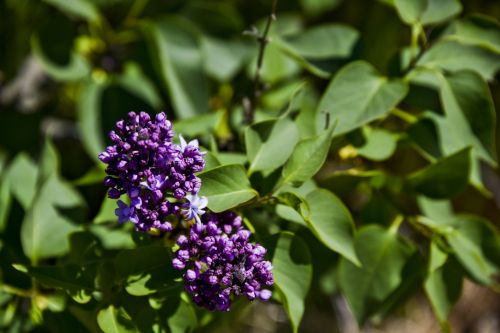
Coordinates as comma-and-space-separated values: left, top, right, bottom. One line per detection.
408, 148, 470, 199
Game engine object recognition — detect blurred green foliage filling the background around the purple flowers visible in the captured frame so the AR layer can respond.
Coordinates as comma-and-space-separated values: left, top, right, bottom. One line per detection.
0, 0, 500, 333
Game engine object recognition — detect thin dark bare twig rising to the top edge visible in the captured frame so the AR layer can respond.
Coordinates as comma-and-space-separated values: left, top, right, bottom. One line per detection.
243, 0, 278, 124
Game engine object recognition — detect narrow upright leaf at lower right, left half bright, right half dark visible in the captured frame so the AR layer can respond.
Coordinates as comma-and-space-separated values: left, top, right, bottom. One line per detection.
424, 242, 463, 332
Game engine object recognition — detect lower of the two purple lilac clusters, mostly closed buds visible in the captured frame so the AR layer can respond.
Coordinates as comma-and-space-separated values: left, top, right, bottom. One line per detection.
172, 211, 274, 311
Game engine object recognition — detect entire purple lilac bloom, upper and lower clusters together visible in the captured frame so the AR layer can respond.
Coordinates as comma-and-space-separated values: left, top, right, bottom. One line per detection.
99, 112, 273, 311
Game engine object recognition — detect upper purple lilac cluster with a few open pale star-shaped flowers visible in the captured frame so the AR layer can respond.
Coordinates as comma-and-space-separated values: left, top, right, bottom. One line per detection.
99, 112, 206, 232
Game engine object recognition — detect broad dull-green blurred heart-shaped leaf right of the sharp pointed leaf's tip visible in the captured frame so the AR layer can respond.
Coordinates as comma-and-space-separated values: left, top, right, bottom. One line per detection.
338, 225, 414, 324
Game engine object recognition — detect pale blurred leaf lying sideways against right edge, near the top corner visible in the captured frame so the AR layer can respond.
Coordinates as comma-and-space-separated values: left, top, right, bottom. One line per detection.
417, 40, 500, 81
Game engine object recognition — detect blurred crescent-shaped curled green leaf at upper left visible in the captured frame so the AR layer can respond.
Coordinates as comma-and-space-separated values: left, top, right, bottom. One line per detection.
31, 35, 90, 81
